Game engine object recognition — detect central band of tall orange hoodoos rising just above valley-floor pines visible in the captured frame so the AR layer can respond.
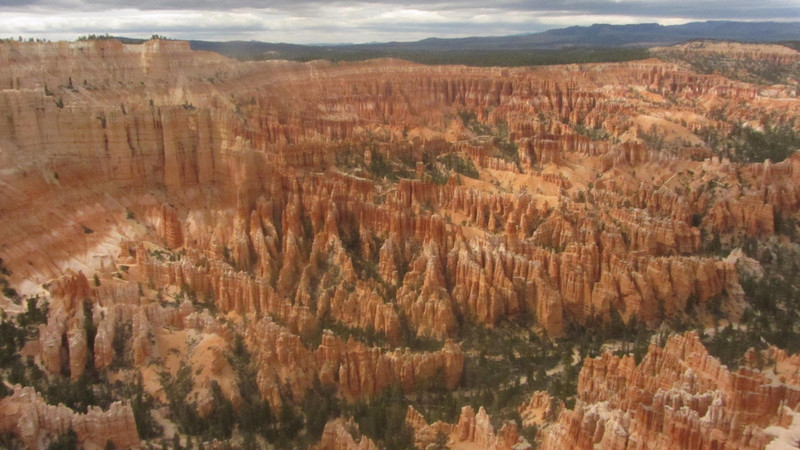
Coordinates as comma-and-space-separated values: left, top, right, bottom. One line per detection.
97, 163, 741, 343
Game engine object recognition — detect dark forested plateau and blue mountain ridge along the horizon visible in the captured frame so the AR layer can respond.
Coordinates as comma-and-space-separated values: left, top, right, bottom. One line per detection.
115, 21, 800, 66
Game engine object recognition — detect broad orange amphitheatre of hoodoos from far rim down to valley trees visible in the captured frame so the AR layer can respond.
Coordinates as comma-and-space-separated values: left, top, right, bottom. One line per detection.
0, 41, 788, 344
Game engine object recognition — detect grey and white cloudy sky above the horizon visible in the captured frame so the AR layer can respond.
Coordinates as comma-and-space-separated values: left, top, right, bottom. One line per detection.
0, 0, 800, 44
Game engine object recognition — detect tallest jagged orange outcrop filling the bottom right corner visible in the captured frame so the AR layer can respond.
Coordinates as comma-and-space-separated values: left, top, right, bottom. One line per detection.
540, 333, 800, 448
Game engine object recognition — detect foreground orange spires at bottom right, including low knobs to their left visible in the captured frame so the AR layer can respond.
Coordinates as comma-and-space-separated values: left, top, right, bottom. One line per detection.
396, 332, 800, 449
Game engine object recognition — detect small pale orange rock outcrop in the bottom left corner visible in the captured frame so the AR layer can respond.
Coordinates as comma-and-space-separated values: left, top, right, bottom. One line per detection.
0, 386, 139, 449
